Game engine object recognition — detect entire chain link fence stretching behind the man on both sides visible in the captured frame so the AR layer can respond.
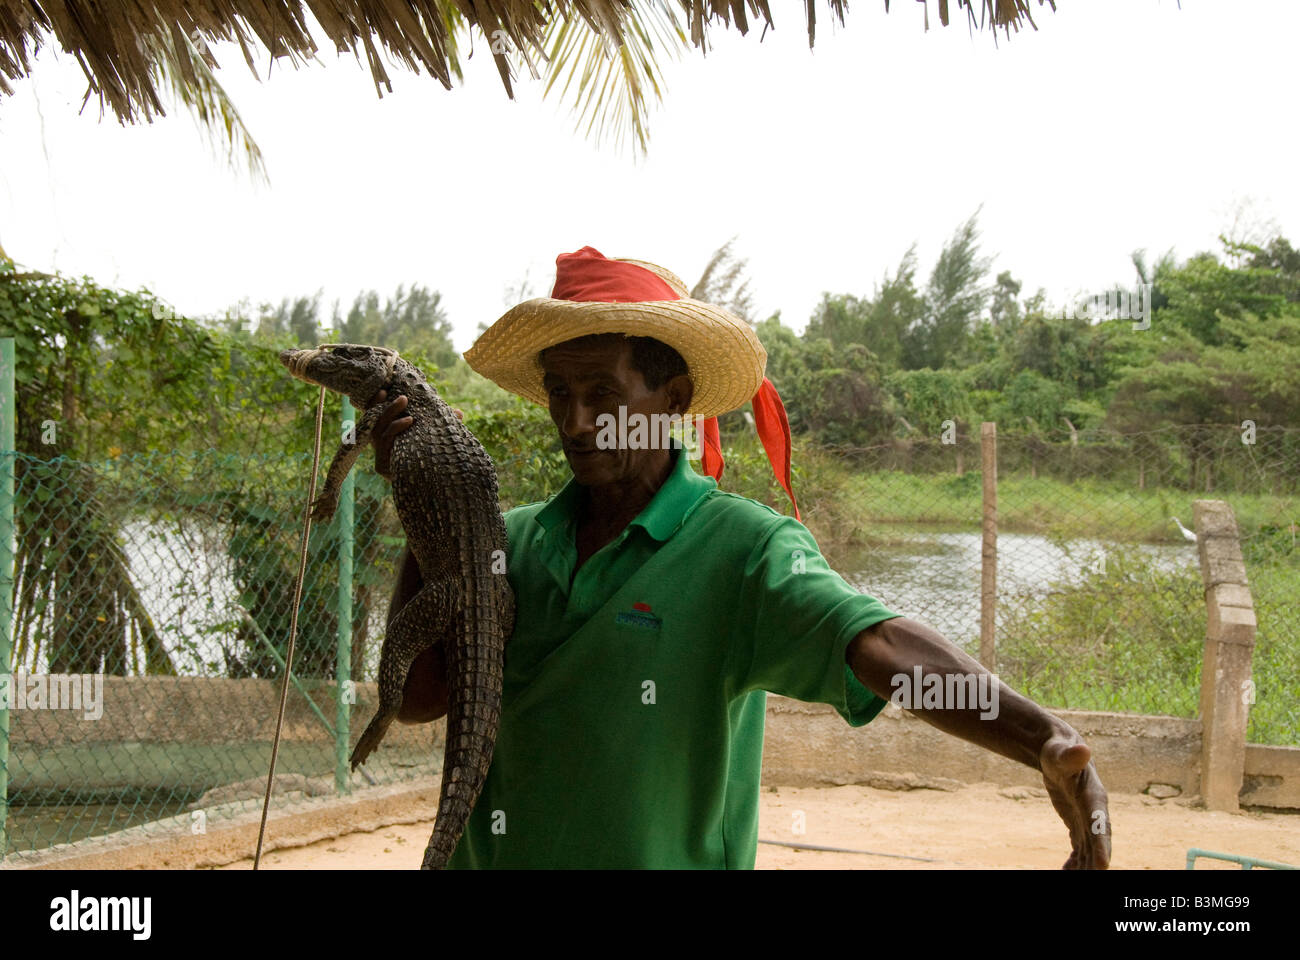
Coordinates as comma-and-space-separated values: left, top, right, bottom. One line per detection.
4, 411, 1300, 861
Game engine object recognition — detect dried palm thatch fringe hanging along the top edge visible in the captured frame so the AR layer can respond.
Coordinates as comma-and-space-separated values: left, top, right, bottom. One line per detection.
0, 0, 1056, 150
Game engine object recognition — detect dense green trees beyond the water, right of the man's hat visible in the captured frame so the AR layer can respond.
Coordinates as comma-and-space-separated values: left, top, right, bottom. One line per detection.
754, 217, 1300, 447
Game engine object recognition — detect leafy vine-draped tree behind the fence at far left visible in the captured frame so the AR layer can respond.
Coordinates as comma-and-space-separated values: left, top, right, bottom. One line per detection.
0, 252, 416, 676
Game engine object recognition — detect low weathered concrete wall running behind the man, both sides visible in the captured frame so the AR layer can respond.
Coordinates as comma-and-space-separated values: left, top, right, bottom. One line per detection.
10, 676, 1300, 809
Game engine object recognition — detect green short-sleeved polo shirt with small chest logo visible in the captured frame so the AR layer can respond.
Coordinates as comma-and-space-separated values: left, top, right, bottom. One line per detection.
449, 449, 897, 869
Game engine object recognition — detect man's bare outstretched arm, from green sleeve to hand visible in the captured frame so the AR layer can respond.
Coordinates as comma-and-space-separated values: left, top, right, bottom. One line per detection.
845, 617, 1110, 870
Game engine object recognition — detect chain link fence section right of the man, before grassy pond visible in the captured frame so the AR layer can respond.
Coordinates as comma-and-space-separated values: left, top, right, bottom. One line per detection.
800, 425, 1300, 744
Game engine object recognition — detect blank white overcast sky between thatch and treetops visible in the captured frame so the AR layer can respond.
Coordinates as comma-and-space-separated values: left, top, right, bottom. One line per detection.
0, 0, 1300, 350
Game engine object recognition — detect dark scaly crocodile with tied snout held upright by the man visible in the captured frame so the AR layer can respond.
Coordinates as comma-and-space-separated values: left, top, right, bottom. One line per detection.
280, 343, 515, 870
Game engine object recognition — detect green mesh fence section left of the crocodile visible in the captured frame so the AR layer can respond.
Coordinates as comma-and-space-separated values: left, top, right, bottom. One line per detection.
5, 449, 441, 857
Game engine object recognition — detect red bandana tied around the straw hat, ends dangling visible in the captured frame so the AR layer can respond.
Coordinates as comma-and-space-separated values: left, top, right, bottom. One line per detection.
551, 247, 802, 519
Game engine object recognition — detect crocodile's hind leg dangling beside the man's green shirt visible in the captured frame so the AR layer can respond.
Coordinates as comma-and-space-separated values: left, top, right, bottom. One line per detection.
351, 580, 462, 770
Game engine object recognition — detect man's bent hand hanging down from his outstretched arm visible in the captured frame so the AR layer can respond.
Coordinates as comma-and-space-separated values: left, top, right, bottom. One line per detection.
1039, 728, 1110, 870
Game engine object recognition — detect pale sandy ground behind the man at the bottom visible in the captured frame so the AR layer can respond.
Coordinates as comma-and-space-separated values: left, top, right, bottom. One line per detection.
222, 783, 1300, 870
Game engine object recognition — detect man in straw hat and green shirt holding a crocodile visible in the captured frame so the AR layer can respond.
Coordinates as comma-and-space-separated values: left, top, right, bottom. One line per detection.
364, 247, 1110, 869
